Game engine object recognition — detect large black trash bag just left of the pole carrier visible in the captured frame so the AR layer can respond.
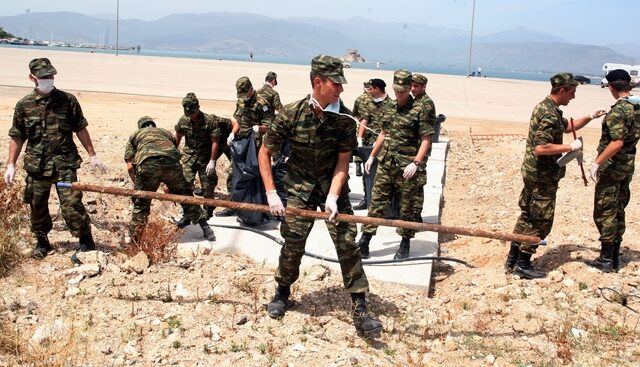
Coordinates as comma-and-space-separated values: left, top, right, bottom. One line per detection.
230, 132, 269, 226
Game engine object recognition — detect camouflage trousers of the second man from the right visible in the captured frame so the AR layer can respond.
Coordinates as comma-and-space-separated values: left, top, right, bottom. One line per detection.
513, 179, 558, 254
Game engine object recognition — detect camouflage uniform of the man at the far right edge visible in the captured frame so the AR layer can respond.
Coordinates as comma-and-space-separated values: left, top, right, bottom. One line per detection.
593, 99, 640, 244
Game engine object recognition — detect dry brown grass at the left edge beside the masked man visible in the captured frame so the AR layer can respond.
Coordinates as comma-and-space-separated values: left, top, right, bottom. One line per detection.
0, 180, 27, 277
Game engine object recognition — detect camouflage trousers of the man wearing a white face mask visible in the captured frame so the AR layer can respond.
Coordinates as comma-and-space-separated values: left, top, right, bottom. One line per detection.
23, 169, 91, 237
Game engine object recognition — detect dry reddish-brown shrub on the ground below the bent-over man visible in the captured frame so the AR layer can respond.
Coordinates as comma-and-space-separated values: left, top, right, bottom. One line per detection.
122, 215, 179, 264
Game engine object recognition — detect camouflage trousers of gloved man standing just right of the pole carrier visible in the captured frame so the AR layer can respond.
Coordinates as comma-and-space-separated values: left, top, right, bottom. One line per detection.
362, 159, 426, 238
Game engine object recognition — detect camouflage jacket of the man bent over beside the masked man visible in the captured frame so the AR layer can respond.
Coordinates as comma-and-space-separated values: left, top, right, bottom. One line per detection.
124, 127, 180, 166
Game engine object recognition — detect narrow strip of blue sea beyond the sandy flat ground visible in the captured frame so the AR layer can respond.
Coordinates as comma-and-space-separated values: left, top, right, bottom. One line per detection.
0, 44, 599, 83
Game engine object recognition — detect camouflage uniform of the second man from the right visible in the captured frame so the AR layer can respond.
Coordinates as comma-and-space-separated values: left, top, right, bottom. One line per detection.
513, 96, 568, 254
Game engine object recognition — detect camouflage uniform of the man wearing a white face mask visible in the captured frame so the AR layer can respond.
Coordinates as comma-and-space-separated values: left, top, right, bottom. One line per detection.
9, 89, 91, 237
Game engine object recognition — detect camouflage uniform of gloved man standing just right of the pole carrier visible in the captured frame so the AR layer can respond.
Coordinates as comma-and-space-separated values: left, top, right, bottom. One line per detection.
362, 76, 433, 238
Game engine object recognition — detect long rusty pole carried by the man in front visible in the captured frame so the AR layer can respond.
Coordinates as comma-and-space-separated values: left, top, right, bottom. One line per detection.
57, 182, 541, 243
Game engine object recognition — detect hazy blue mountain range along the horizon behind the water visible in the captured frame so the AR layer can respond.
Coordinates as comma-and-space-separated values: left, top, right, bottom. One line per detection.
0, 12, 640, 75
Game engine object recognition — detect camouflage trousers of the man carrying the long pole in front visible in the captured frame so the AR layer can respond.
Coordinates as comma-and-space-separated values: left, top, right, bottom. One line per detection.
275, 186, 369, 293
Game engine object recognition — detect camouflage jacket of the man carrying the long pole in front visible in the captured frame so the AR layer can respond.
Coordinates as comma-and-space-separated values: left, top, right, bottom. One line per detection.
263, 96, 357, 201
